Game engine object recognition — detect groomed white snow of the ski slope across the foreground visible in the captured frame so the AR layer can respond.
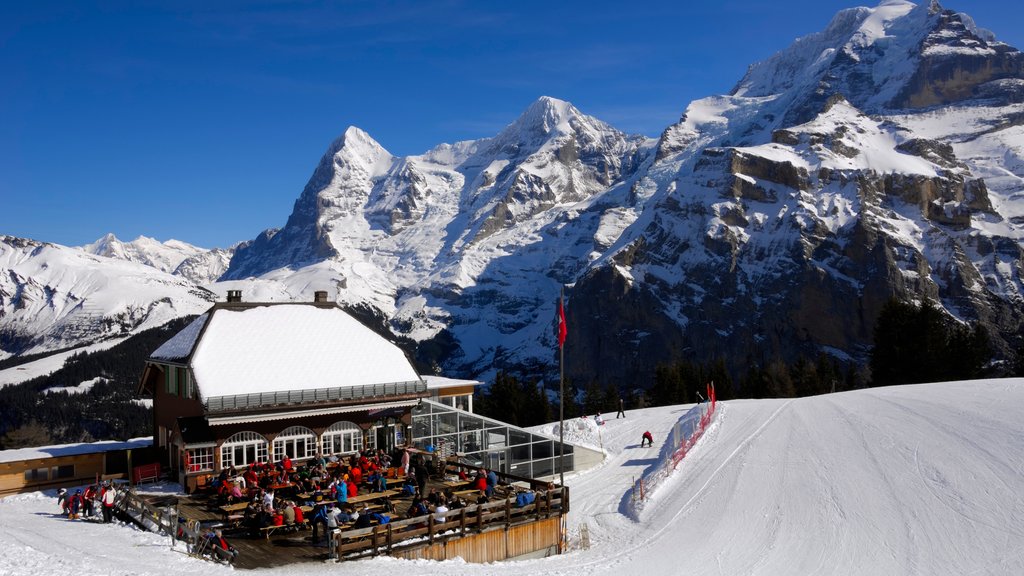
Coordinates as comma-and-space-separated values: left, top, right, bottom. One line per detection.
0, 378, 1024, 576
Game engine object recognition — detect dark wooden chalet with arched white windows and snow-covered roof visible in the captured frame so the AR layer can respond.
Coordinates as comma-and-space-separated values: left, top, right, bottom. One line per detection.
139, 290, 432, 491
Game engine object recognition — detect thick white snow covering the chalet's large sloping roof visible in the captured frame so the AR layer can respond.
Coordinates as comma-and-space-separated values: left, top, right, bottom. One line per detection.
184, 303, 420, 399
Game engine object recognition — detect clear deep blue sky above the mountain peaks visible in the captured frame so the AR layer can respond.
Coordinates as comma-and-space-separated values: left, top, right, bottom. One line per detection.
0, 0, 1024, 248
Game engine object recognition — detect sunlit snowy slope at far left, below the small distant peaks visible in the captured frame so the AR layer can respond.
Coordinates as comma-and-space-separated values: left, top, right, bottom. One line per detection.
0, 236, 215, 355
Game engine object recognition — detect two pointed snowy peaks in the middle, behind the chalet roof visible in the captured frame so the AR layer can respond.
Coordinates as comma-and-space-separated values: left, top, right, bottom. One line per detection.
224, 97, 652, 369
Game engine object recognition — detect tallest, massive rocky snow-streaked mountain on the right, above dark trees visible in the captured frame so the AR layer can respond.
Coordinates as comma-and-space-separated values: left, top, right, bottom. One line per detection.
569, 2, 1024, 379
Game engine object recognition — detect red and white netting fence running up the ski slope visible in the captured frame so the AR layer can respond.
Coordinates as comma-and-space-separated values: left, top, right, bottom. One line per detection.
632, 384, 717, 518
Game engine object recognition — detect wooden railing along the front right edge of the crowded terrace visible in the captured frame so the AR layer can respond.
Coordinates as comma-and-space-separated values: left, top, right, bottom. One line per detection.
333, 481, 568, 560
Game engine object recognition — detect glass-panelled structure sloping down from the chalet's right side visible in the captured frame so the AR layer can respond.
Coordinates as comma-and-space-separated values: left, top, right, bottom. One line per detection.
413, 400, 574, 479
